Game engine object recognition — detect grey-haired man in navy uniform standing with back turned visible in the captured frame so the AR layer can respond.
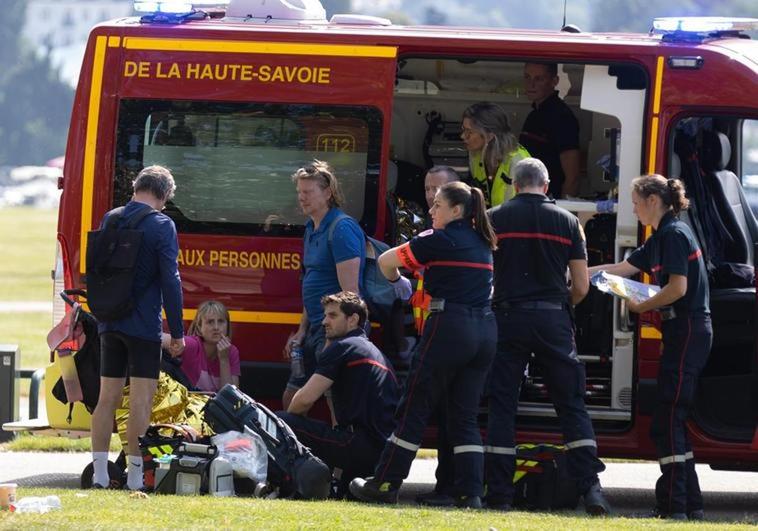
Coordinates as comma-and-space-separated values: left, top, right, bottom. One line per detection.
485, 158, 610, 514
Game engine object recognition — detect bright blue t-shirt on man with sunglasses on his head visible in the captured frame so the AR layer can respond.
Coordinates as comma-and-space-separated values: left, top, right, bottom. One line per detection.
303, 208, 366, 326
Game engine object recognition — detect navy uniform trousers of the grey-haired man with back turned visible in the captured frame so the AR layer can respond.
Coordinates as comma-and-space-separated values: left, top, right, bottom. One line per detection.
485, 308, 605, 505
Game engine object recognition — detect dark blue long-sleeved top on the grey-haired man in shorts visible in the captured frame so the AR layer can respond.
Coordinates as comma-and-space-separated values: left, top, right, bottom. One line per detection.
98, 201, 184, 341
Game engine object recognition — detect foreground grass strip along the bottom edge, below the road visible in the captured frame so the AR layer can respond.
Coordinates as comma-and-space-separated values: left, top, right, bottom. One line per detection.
0, 488, 750, 531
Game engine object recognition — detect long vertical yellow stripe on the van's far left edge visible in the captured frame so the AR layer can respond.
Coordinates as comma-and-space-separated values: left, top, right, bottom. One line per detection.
79, 36, 108, 273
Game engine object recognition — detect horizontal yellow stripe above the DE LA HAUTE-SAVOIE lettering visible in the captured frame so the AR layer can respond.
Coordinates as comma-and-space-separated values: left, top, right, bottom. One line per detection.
124, 37, 397, 59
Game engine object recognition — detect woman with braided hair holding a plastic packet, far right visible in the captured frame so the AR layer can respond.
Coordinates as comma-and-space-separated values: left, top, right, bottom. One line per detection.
590, 175, 713, 520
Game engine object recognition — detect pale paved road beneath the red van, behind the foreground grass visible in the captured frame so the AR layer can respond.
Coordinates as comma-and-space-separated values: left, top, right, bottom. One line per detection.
0, 452, 758, 524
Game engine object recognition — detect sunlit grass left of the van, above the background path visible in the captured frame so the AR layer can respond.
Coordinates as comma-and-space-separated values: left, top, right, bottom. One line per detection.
0, 207, 58, 302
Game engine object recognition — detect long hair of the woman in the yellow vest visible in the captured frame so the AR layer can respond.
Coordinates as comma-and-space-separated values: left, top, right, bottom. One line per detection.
463, 101, 518, 172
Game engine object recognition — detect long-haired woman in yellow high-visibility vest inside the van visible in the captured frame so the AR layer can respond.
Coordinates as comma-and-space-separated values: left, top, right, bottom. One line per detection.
461, 101, 529, 207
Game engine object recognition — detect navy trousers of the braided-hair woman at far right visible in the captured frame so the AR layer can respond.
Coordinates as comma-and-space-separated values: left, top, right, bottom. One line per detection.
650, 315, 713, 514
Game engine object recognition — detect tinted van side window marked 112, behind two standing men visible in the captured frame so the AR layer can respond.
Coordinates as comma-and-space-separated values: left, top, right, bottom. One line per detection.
113, 100, 382, 236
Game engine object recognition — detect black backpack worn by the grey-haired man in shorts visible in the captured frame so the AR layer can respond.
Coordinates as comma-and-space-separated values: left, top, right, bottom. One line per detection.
87, 205, 158, 322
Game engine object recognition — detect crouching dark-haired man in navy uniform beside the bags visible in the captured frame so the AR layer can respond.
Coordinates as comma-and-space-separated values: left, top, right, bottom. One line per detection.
277, 291, 400, 495
